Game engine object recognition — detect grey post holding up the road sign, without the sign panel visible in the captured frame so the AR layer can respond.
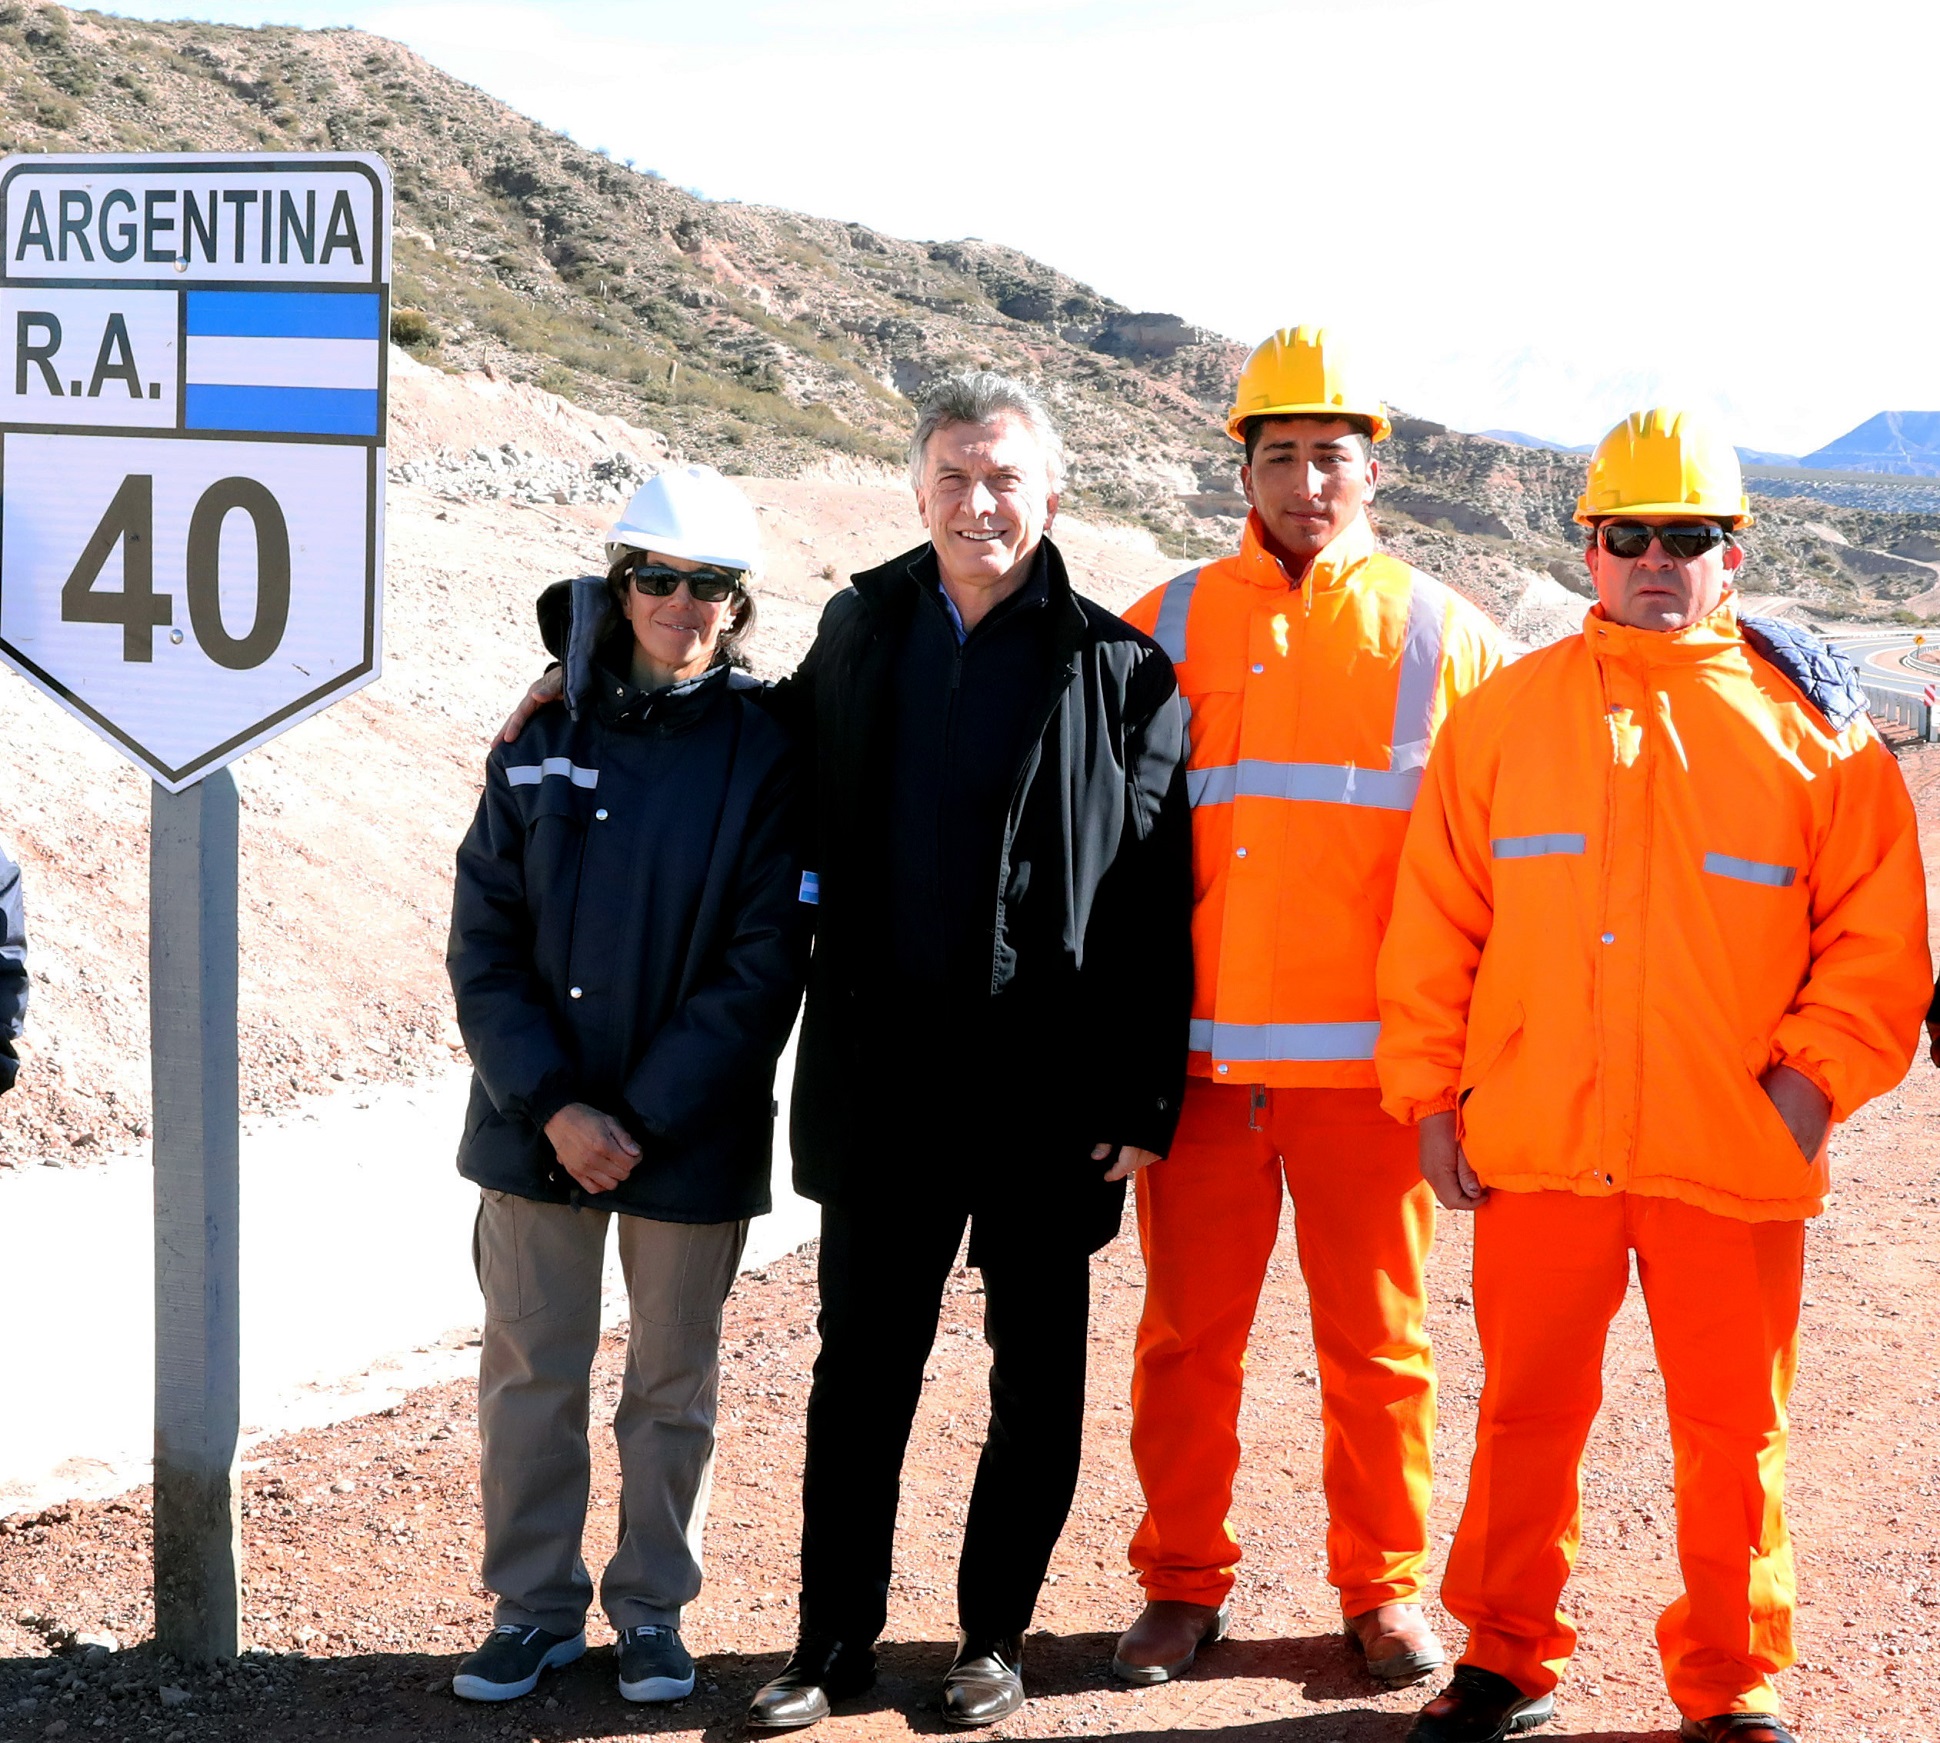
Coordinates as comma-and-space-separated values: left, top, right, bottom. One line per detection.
147, 769, 243, 1663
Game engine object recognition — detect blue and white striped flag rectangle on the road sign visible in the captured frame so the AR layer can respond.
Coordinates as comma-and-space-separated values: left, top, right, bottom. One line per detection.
182, 291, 384, 439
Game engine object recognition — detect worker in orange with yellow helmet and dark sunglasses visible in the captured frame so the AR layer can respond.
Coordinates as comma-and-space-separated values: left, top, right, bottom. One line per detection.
1375, 410, 1932, 1743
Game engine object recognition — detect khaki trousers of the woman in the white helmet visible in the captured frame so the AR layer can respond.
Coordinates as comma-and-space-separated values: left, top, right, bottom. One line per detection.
471, 1192, 747, 1634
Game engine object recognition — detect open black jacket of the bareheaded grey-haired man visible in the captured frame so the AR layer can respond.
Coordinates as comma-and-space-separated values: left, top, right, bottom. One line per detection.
770, 542, 1193, 1244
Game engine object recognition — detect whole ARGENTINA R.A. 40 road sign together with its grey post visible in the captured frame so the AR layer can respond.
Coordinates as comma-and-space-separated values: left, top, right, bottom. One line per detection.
0, 153, 390, 1660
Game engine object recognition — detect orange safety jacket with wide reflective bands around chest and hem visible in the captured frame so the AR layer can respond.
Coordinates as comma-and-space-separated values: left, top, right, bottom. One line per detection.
1125, 516, 1502, 1089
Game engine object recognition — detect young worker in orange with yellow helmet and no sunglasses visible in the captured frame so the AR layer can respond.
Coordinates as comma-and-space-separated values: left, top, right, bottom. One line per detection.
1112, 326, 1502, 1683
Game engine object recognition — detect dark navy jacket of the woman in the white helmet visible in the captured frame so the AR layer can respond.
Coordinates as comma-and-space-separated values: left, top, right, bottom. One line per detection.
448, 613, 809, 1223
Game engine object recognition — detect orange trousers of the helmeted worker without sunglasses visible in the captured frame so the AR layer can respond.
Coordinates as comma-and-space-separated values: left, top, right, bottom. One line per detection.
1131, 1077, 1436, 1615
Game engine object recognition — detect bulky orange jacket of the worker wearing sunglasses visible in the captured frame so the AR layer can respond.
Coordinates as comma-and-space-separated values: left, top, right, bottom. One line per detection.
1375, 598, 1932, 1223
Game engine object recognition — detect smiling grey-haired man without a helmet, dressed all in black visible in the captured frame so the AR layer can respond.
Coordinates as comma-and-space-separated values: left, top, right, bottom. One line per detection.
749, 373, 1191, 1729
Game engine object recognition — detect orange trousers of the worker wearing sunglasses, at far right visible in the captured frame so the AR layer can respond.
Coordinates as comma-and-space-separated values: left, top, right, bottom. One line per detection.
1441, 1192, 1804, 1720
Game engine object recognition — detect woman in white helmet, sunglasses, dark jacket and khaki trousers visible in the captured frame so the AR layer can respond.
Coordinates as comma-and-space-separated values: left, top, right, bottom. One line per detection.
450, 466, 807, 1700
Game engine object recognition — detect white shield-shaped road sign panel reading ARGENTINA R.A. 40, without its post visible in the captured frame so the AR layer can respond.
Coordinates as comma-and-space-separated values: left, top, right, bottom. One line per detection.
0, 153, 390, 792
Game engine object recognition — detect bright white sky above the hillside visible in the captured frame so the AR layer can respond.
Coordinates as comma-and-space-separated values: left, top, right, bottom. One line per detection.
113, 0, 1940, 454
